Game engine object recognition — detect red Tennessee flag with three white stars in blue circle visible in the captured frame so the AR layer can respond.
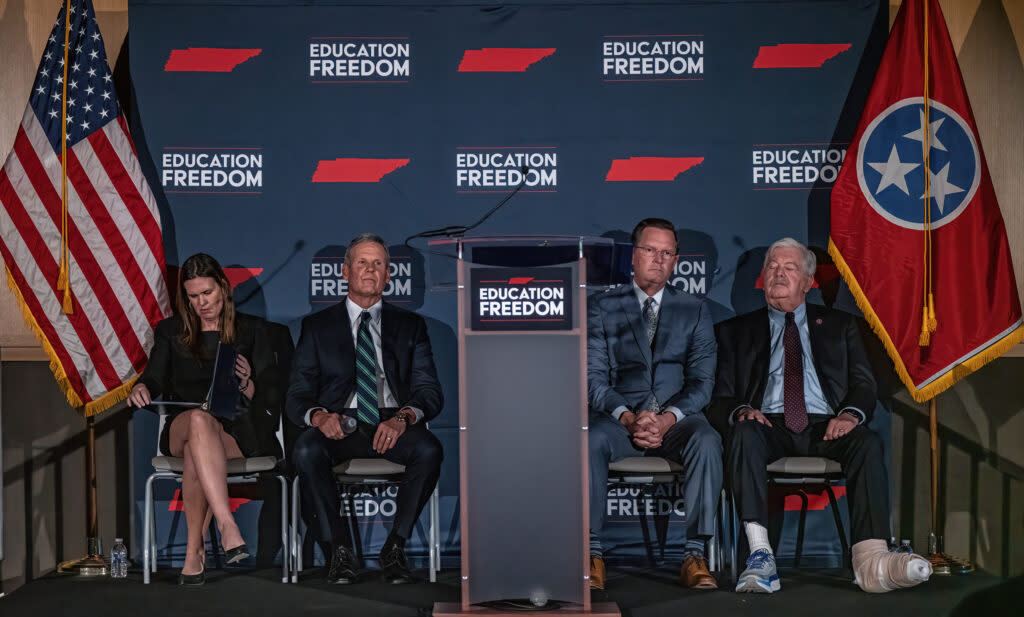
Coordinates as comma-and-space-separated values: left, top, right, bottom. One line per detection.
828, 0, 1024, 401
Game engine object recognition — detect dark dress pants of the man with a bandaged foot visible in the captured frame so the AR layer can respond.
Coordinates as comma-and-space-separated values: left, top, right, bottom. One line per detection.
727, 413, 890, 544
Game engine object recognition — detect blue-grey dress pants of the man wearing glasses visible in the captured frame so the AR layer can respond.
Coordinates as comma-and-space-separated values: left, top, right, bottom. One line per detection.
587, 412, 722, 539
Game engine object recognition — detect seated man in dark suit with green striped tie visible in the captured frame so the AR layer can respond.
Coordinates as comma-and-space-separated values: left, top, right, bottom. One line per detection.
286, 233, 443, 584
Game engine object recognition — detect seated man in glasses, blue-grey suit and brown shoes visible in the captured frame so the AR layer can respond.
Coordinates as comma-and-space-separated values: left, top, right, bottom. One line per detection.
587, 218, 722, 589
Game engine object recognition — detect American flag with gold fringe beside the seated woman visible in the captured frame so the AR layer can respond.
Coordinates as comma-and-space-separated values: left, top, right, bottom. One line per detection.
0, 0, 170, 415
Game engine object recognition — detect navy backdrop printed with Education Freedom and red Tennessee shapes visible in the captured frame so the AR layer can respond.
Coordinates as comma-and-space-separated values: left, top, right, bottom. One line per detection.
123, 0, 888, 562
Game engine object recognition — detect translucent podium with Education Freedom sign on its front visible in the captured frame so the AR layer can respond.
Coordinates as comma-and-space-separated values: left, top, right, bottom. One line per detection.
430, 236, 620, 617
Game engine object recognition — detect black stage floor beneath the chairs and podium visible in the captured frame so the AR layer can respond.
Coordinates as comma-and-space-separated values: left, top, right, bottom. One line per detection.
0, 569, 1024, 617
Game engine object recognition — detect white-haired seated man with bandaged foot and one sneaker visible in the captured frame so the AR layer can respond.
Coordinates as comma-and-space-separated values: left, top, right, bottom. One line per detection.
708, 237, 932, 593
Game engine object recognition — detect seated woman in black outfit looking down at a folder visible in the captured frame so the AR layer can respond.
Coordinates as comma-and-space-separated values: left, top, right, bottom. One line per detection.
129, 253, 281, 585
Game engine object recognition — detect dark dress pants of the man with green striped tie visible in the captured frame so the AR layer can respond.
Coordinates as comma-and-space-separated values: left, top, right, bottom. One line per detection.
292, 423, 443, 548
